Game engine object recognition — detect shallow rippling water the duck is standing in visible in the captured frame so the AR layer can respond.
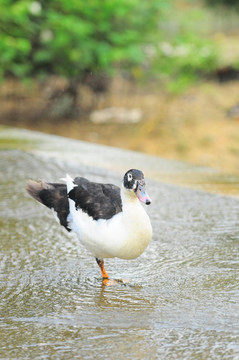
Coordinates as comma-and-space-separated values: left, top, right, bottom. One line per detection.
0, 130, 239, 360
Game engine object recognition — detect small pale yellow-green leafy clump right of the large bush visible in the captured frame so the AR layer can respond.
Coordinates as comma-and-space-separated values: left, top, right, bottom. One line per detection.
153, 31, 218, 93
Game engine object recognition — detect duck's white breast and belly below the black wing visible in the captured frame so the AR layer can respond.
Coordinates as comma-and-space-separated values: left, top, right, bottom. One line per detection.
68, 200, 152, 259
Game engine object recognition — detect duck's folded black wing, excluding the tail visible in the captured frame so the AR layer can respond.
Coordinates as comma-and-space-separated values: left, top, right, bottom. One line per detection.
68, 177, 122, 220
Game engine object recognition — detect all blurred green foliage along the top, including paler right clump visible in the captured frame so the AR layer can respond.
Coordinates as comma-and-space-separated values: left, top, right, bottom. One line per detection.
0, 0, 217, 91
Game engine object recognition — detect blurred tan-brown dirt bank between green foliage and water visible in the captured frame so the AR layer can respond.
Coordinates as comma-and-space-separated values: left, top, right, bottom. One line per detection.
0, 78, 239, 173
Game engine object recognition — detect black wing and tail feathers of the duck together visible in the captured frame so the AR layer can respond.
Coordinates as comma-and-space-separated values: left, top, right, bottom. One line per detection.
27, 177, 122, 231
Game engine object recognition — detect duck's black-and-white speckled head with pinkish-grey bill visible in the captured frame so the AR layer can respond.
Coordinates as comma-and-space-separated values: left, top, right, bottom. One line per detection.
123, 169, 151, 205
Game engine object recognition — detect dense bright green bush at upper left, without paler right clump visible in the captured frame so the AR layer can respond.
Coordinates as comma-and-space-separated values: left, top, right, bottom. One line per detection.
0, 0, 166, 78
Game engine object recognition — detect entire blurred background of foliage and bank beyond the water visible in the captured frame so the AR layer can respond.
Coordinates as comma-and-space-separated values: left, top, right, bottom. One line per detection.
0, 0, 239, 174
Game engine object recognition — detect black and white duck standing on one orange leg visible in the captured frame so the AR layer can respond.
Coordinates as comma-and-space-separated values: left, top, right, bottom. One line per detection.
26, 169, 152, 281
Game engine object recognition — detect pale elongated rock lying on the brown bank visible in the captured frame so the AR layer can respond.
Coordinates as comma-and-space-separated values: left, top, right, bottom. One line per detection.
90, 107, 142, 124
